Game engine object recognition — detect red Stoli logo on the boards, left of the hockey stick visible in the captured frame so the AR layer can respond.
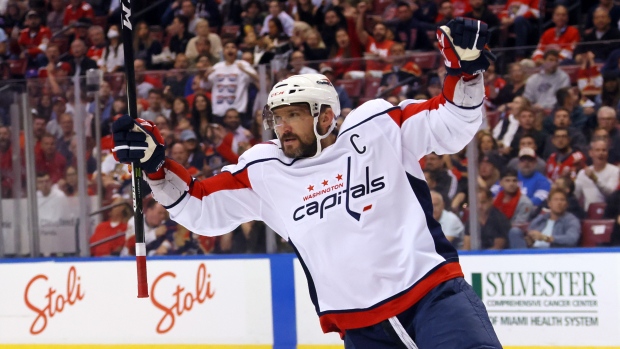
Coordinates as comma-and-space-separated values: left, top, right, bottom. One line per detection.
24, 266, 84, 335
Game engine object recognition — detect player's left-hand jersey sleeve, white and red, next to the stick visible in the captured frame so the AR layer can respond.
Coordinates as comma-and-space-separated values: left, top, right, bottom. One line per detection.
146, 154, 261, 236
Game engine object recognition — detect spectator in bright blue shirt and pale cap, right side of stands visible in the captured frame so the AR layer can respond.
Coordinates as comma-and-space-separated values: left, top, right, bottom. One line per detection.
518, 148, 551, 206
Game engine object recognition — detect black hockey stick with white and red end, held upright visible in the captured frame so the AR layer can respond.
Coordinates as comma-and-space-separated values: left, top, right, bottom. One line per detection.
121, 0, 149, 298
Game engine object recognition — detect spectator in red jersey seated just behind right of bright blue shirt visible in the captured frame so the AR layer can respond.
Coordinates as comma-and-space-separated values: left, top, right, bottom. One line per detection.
547, 128, 586, 181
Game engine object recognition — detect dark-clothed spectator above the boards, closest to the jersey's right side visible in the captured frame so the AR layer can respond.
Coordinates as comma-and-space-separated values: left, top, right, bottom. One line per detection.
463, 189, 510, 250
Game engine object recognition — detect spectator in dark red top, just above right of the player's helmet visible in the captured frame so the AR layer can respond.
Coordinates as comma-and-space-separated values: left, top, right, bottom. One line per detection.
328, 28, 362, 79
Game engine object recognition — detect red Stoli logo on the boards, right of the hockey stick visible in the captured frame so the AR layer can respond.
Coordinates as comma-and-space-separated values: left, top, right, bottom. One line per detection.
151, 263, 215, 334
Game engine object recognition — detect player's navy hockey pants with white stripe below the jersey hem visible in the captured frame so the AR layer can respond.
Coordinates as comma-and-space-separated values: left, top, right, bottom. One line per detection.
344, 278, 502, 349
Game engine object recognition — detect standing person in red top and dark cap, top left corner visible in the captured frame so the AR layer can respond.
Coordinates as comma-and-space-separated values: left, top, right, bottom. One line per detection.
17, 10, 52, 68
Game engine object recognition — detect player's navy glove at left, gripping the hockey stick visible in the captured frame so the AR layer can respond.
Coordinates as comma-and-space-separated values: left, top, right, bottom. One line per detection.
112, 115, 166, 175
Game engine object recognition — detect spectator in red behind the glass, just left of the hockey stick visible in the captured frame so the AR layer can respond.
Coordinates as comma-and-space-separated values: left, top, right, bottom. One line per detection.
90, 197, 132, 257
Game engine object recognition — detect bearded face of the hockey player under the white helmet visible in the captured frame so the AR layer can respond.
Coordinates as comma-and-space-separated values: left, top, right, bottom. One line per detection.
272, 105, 323, 158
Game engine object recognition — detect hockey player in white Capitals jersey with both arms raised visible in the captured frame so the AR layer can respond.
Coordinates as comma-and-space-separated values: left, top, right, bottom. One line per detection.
114, 18, 501, 349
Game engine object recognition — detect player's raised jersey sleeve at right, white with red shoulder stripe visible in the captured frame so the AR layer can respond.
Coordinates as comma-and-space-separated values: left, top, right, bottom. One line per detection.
388, 74, 484, 160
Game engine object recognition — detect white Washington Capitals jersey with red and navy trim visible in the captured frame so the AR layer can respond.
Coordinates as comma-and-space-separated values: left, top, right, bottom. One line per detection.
149, 76, 484, 333
